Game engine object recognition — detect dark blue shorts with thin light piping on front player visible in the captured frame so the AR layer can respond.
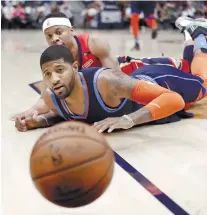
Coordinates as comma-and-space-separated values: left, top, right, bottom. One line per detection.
132, 65, 206, 103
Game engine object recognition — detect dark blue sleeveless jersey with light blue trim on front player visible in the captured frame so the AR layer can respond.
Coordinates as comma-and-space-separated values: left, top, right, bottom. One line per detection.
49, 67, 143, 124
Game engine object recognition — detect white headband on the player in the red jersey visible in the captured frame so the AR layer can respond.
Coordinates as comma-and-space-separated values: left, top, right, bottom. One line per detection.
42, 17, 72, 32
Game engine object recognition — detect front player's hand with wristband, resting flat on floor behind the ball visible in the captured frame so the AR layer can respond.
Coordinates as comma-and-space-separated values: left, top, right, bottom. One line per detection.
94, 117, 133, 133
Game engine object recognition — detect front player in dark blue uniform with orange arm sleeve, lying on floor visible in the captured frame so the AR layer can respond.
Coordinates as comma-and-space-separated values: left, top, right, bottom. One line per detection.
15, 26, 207, 132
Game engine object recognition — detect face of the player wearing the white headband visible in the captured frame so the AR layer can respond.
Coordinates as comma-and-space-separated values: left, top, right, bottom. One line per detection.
44, 25, 73, 46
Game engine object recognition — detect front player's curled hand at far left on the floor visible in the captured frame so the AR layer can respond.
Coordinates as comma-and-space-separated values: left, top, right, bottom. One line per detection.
15, 116, 47, 132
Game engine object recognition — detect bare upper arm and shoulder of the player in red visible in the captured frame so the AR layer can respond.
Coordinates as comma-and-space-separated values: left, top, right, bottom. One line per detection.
89, 35, 121, 72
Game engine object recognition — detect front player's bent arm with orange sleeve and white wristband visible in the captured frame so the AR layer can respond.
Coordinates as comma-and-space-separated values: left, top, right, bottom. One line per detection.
94, 73, 185, 132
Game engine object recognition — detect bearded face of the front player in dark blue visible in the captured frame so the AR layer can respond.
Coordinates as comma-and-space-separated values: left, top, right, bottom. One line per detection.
42, 59, 78, 99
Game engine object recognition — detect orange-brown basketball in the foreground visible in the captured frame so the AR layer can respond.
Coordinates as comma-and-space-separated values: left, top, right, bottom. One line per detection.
30, 122, 114, 208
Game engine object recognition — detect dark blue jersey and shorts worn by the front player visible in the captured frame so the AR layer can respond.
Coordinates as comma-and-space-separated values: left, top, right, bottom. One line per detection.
49, 65, 206, 124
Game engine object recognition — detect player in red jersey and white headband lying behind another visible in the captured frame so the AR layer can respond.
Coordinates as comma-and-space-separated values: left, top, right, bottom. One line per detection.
13, 13, 207, 119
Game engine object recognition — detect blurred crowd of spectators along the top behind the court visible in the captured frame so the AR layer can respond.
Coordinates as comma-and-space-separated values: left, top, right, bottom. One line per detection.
1, 0, 207, 29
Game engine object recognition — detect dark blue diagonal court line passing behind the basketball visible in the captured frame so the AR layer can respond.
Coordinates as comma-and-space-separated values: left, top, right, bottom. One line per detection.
29, 81, 190, 215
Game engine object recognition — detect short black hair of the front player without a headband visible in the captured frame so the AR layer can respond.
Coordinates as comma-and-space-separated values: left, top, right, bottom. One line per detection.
40, 45, 74, 68
